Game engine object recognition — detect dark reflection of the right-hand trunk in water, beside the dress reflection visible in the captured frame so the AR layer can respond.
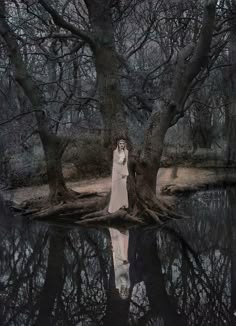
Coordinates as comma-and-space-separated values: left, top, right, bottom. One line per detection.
131, 230, 187, 326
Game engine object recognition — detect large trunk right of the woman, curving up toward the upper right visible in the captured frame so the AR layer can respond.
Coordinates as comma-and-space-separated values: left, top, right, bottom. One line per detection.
130, 1, 216, 218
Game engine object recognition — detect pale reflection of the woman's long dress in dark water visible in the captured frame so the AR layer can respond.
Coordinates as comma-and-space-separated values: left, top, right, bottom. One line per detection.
109, 228, 130, 299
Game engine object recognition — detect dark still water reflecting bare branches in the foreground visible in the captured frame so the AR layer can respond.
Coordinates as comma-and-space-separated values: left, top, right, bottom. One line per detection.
0, 189, 236, 326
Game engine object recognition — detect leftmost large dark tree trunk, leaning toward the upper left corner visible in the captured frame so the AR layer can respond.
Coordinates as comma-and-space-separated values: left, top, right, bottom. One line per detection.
0, 1, 73, 202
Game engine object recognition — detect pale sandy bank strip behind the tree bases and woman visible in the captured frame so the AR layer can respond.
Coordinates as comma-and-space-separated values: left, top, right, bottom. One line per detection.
1, 167, 236, 205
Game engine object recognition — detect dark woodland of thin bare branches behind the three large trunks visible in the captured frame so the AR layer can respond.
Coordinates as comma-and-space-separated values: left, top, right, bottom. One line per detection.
0, 0, 236, 191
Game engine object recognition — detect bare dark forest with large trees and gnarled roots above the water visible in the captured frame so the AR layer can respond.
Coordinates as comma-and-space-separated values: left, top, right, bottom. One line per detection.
0, 0, 236, 225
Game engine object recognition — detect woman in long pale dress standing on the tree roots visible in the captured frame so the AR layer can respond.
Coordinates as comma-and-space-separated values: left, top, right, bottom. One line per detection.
108, 139, 129, 213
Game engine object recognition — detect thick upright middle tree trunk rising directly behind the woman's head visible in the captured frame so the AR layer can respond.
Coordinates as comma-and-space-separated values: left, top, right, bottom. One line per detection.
85, 0, 127, 147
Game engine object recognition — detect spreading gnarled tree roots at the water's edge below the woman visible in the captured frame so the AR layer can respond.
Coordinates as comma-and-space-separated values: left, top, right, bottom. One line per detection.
18, 188, 186, 226
